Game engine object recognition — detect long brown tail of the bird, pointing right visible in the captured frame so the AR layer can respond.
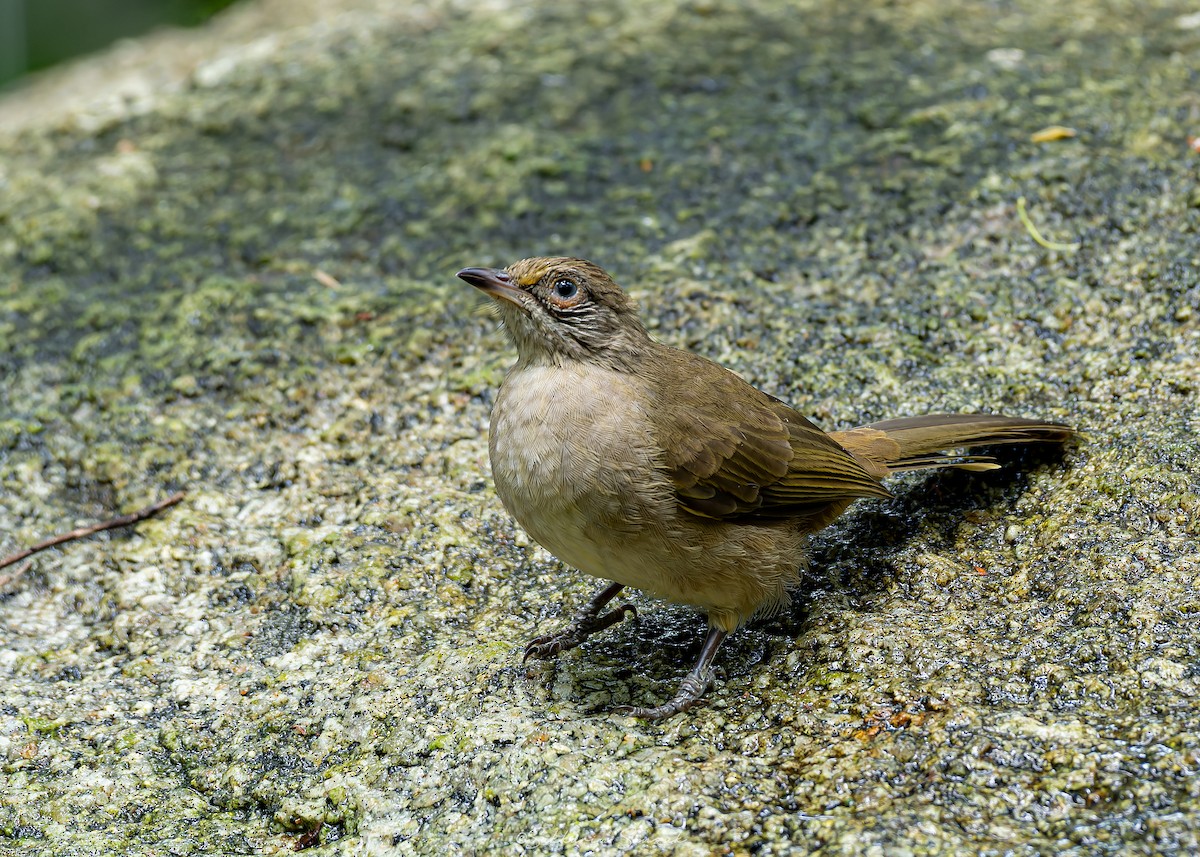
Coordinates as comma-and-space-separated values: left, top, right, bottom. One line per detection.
830, 414, 1075, 478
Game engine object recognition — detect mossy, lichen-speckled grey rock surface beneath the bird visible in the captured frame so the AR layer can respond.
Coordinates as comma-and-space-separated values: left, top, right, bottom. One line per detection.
0, 0, 1200, 855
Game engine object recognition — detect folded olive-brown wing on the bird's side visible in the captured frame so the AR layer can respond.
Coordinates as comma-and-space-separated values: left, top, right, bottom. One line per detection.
658, 347, 890, 519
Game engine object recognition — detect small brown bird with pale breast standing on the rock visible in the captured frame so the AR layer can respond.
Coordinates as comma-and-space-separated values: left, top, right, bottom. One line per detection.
457, 257, 1075, 720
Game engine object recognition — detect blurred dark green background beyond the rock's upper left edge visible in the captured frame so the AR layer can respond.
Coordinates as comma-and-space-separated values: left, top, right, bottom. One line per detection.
0, 0, 241, 86
